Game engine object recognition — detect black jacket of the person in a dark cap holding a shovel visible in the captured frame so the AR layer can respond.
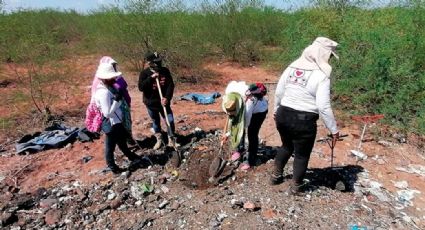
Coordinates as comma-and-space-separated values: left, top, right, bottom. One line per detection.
138, 67, 174, 109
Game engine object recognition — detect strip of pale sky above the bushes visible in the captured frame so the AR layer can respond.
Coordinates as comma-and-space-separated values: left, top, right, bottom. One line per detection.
4, 0, 306, 12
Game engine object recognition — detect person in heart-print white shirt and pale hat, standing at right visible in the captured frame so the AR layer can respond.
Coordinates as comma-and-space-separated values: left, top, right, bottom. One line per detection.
271, 37, 339, 193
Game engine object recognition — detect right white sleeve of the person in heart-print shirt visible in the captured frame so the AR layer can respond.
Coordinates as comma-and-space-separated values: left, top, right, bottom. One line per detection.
316, 78, 338, 134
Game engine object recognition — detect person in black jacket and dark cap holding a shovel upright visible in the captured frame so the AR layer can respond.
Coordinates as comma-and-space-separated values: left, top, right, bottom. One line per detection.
138, 52, 177, 150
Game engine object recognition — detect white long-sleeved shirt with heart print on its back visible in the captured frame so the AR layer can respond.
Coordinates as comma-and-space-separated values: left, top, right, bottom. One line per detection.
274, 67, 338, 134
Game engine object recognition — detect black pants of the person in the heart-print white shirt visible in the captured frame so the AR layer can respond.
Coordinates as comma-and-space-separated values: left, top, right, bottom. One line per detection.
274, 106, 319, 184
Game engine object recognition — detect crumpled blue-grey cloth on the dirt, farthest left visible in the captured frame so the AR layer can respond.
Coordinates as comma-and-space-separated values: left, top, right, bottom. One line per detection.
15, 124, 79, 154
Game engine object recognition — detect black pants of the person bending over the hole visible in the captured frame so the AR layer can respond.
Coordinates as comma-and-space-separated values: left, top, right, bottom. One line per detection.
243, 111, 267, 166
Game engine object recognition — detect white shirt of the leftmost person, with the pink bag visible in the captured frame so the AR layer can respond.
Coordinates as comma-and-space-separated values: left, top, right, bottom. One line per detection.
94, 83, 122, 125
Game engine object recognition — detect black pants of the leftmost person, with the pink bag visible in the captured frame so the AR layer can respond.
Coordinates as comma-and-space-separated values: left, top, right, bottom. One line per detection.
105, 123, 138, 168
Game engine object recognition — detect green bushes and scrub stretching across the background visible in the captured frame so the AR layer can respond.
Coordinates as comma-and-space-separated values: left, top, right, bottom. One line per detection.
0, 0, 425, 134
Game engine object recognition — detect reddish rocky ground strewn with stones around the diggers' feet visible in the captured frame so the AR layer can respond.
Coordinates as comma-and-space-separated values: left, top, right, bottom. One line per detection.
0, 59, 425, 229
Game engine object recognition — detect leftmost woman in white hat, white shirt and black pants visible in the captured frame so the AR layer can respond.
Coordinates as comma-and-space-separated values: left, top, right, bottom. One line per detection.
94, 60, 141, 174
